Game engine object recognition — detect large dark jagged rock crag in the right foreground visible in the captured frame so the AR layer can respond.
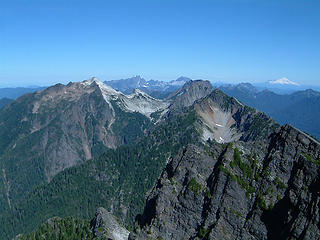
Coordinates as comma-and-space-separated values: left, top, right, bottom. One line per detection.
129, 125, 320, 240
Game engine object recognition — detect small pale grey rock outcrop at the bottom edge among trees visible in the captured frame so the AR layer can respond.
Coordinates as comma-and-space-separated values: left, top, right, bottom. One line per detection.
91, 208, 129, 240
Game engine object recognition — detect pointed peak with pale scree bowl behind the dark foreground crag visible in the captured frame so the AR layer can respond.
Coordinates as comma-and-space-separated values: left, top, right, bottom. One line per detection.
194, 89, 277, 143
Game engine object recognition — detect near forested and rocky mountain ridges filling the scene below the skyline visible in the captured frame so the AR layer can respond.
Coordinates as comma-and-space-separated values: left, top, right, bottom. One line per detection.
0, 78, 320, 240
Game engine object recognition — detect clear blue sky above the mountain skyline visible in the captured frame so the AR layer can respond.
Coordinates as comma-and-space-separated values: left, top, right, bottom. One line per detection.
0, 0, 320, 86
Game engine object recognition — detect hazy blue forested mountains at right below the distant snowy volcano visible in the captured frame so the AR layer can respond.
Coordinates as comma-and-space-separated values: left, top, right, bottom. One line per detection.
219, 83, 320, 139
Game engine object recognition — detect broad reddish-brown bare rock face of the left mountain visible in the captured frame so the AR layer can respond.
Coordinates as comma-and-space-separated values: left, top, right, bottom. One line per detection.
31, 83, 116, 179
